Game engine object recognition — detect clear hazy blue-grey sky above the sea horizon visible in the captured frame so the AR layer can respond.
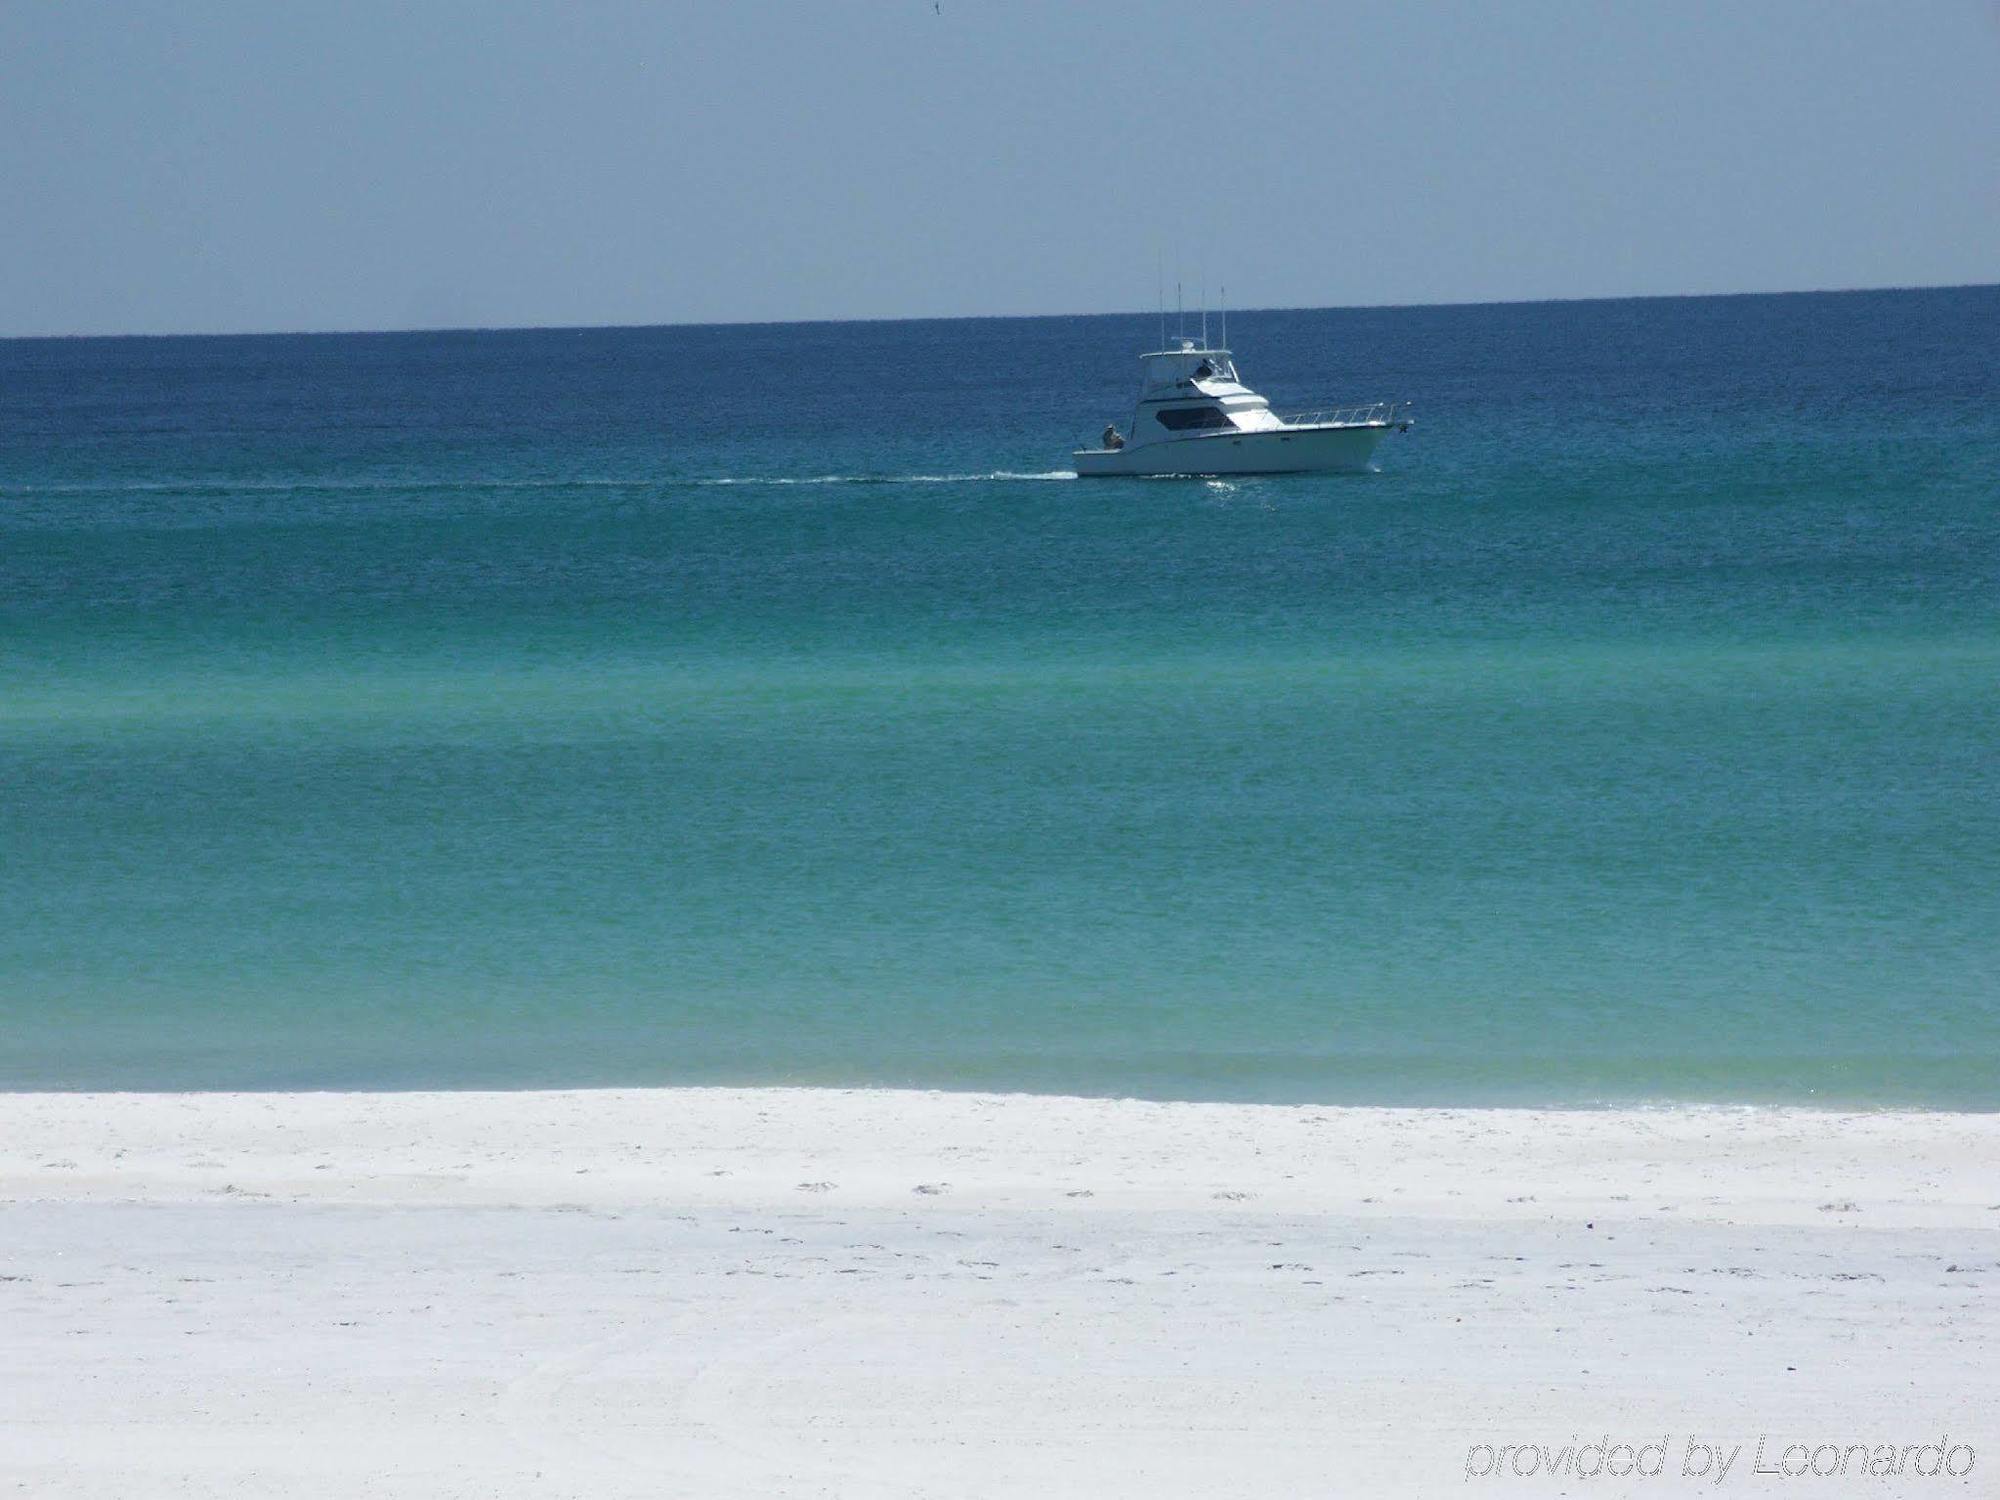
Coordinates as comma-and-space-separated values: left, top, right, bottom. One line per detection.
0, 0, 2000, 334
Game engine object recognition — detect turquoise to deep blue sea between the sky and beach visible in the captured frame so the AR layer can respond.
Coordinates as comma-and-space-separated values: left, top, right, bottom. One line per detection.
0, 288, 2000, 1108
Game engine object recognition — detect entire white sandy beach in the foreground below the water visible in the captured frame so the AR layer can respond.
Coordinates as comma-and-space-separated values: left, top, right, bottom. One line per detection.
0, 1090, 2000, 1496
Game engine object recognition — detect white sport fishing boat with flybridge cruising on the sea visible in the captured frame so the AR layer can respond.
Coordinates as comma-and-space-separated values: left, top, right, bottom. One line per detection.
1074, 338, 1412, 478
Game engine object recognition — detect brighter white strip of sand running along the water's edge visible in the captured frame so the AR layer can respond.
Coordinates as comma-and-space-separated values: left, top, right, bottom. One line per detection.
0, 1088, 2000, 1228
